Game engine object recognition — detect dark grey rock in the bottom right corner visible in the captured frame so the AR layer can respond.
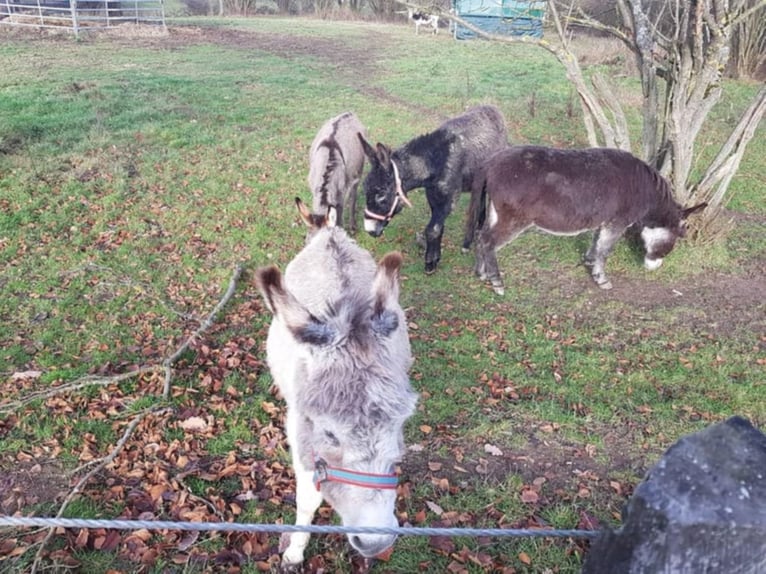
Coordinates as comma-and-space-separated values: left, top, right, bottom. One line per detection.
582, 417, 766, 574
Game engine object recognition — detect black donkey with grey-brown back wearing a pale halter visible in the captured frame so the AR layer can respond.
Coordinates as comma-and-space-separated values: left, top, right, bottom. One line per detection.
359, 106, 508, 274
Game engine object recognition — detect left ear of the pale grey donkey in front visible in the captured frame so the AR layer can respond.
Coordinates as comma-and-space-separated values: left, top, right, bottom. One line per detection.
255, 265, 336, 345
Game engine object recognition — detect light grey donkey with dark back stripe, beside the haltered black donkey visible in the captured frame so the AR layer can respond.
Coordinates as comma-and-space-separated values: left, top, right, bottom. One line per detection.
308, 112, 367, 232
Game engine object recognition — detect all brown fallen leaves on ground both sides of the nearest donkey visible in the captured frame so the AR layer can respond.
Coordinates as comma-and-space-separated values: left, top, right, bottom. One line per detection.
0, 294, 626, 574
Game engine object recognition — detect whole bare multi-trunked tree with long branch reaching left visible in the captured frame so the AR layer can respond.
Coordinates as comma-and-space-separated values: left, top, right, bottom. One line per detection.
426, 0, 766, 224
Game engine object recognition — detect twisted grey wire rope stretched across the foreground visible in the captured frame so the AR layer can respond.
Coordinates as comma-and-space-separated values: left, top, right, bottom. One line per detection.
0, 516, 599, 539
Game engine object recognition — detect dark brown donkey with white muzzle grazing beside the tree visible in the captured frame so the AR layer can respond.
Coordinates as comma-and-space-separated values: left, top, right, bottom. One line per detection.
463, 146, 707, 295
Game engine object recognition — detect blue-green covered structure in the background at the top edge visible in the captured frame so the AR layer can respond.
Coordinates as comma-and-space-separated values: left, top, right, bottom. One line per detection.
452, 0, 547, 40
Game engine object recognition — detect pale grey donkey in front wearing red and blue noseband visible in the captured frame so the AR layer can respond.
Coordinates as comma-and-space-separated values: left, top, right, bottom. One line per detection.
256, 200, 417, 568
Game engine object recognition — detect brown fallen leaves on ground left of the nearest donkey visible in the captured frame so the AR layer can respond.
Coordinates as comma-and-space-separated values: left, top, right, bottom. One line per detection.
0, 304, 294, 572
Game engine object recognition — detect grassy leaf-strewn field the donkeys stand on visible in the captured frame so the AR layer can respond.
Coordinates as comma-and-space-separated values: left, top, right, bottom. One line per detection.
0, 18, 766, 574
